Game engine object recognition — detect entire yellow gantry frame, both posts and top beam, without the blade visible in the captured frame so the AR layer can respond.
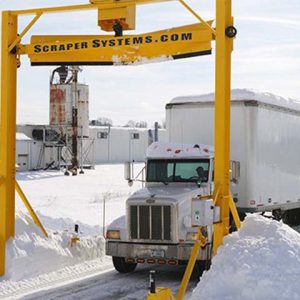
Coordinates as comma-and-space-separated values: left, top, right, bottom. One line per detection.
0, 0, 239, 292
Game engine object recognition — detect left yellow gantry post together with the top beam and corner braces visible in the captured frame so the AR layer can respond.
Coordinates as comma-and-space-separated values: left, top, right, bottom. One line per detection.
0, 0, 214, 276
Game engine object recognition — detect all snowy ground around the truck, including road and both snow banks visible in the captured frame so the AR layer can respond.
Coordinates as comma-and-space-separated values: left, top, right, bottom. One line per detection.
0, 165, 300, 300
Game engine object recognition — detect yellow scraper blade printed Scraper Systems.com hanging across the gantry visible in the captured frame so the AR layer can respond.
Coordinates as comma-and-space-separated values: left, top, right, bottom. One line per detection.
20, 22, 213, 65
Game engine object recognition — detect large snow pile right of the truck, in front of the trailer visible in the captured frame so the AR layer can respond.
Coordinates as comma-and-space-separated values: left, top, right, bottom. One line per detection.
190, 215, 300, 300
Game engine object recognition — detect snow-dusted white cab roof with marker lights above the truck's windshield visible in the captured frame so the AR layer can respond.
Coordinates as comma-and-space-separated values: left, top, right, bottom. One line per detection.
146, 142, 214, 158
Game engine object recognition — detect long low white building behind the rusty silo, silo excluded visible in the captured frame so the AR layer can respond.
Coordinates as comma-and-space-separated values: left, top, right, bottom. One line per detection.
16, 125, 166, 171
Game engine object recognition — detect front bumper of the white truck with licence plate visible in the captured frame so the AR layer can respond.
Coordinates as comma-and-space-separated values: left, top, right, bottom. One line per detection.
106, 241, 211, 261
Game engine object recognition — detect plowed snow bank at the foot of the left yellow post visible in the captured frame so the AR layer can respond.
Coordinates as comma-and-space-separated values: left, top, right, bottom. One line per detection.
0, 210, 105, 298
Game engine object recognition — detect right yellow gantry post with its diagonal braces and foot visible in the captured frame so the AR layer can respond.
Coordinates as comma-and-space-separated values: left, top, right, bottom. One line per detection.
148, 0, 240, 300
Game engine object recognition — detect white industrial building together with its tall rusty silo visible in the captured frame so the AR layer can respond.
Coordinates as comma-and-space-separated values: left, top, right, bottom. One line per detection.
16, 66, 166, 175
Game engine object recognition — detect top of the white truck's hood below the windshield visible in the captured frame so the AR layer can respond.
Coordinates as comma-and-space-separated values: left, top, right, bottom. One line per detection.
128, 185, 203, 202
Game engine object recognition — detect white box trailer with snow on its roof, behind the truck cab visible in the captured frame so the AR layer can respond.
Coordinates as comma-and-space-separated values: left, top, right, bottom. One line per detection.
166, 89, 300, 213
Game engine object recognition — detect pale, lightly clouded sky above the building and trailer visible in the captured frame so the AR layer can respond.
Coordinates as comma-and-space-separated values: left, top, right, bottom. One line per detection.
0, 0, 300, 125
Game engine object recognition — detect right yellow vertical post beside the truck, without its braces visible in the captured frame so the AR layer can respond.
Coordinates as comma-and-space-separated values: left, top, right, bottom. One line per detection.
214, 0, 233, 254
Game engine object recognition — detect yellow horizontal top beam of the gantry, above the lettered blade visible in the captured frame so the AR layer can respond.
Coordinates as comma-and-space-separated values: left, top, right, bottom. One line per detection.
10, 0, 175, 16
